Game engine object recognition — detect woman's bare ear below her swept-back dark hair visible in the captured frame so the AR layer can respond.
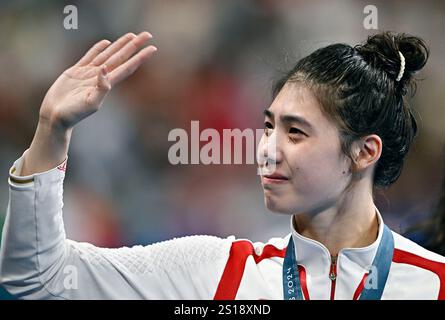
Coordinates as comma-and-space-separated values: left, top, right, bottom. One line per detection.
354, 134, 382, 170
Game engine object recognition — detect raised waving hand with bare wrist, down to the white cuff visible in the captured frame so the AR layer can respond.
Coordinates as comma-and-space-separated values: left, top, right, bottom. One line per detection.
16, 32, 157, 176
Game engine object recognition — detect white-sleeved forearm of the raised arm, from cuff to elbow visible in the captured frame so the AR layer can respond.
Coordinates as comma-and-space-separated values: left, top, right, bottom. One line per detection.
0, 152, 65, 297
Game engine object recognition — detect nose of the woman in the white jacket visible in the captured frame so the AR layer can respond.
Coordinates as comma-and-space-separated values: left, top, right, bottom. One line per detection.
257, 132, 283, 175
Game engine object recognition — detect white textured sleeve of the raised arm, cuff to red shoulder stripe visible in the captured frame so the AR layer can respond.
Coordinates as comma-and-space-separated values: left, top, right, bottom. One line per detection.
0, 151, 234, 299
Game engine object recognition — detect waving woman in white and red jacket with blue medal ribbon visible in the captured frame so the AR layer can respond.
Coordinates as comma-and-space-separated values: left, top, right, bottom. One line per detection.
0, 32, 445, 300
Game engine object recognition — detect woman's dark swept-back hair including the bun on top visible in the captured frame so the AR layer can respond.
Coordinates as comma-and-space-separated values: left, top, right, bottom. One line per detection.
273, 32, 429, 187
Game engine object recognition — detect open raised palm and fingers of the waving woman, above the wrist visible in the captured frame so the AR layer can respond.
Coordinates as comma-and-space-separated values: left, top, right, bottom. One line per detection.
40, 32, 157, 129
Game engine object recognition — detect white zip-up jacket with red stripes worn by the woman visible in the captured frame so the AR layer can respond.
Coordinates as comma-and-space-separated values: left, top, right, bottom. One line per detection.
0, 151, 445, 299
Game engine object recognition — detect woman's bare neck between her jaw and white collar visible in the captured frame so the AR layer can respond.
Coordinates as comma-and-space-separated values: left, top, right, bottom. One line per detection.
293, 189, 379, 257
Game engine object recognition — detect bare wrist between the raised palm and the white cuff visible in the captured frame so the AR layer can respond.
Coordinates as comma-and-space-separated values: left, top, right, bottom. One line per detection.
16, 118, 72, 176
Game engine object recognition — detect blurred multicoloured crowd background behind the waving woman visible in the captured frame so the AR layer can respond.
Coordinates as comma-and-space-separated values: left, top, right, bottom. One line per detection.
0, 0, 445, 255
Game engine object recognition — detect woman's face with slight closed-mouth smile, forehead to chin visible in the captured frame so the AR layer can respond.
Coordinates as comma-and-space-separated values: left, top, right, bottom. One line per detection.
259, 84, 350, 214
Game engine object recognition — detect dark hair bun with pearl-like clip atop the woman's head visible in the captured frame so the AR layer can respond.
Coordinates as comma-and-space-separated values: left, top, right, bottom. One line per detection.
355, 32, 429, 93
